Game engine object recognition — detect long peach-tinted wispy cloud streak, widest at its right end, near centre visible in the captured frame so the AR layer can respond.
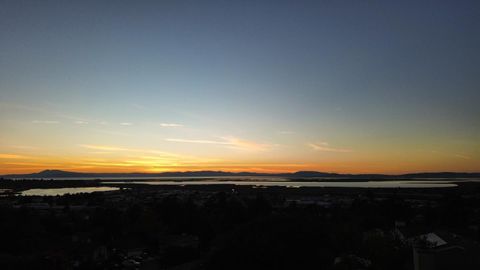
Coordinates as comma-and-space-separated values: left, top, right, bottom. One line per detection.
165, 137, 271, 151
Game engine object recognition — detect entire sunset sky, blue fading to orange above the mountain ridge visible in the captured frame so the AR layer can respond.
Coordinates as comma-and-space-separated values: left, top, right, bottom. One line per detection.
0, 0, 480, 174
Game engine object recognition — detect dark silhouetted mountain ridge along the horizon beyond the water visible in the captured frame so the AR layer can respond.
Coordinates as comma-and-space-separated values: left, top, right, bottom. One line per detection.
0, 170, 480, 179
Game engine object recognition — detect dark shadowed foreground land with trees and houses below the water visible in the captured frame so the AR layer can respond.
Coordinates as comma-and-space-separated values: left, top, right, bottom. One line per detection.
0, 182, 480, 270
